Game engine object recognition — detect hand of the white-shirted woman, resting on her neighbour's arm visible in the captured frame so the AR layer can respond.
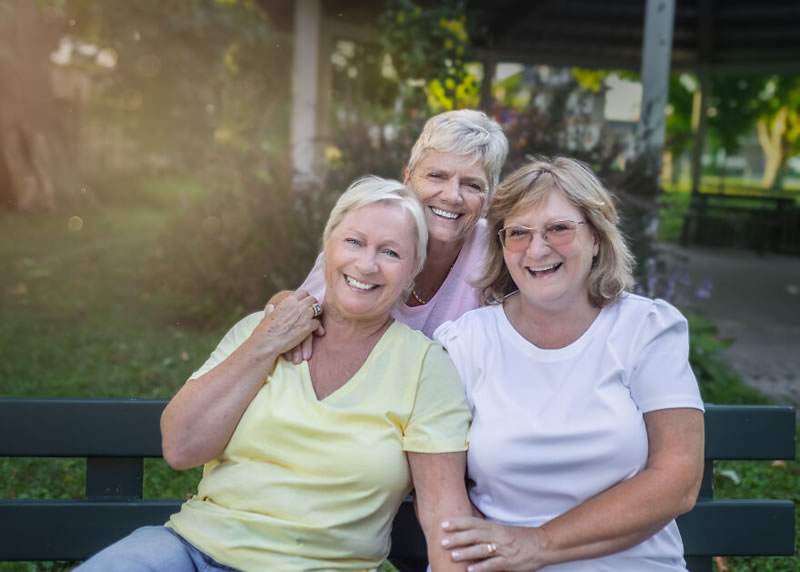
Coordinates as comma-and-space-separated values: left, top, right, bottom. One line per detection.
442, 516, 545, 572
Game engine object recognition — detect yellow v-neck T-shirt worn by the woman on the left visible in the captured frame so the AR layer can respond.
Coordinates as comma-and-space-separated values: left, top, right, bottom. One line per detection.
168, 313, 470, 570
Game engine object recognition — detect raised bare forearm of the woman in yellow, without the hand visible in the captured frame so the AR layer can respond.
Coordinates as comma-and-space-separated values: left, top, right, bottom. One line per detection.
161, 340, 278, 469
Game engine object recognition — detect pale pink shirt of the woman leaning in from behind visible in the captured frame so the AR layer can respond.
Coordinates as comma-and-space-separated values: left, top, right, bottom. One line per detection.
300, 219, 488, 338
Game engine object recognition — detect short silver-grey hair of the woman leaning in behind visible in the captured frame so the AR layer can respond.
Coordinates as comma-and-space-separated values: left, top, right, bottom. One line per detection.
407, 109, 508, 196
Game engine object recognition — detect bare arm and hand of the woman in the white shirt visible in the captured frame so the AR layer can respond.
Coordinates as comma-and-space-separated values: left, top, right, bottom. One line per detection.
445, 408, 704, 572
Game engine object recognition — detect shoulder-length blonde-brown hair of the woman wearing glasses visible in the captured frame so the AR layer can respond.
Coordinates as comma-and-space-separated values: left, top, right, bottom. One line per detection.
476, 157, 634, 308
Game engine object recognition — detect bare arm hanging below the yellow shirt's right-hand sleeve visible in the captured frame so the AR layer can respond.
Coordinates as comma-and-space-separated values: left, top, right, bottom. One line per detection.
407, 452, 472, 572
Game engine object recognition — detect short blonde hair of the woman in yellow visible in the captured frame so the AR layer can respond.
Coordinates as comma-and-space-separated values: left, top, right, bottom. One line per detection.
322, 175, 428, 276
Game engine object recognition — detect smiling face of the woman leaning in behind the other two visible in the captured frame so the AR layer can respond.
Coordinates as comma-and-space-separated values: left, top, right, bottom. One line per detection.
404, 149, 489, 247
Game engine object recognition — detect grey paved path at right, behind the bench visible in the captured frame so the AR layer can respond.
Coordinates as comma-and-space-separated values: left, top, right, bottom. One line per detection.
669, 246, 800, 404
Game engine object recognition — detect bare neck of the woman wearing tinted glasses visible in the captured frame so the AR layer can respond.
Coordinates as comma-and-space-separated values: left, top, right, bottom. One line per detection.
503, 292, 600, 349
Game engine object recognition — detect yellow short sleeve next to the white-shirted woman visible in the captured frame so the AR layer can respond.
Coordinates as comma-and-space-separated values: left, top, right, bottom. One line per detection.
403, 344, 472, 453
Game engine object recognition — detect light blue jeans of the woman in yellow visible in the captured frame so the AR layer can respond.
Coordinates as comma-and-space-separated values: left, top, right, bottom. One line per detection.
75, 526, 235, 572
